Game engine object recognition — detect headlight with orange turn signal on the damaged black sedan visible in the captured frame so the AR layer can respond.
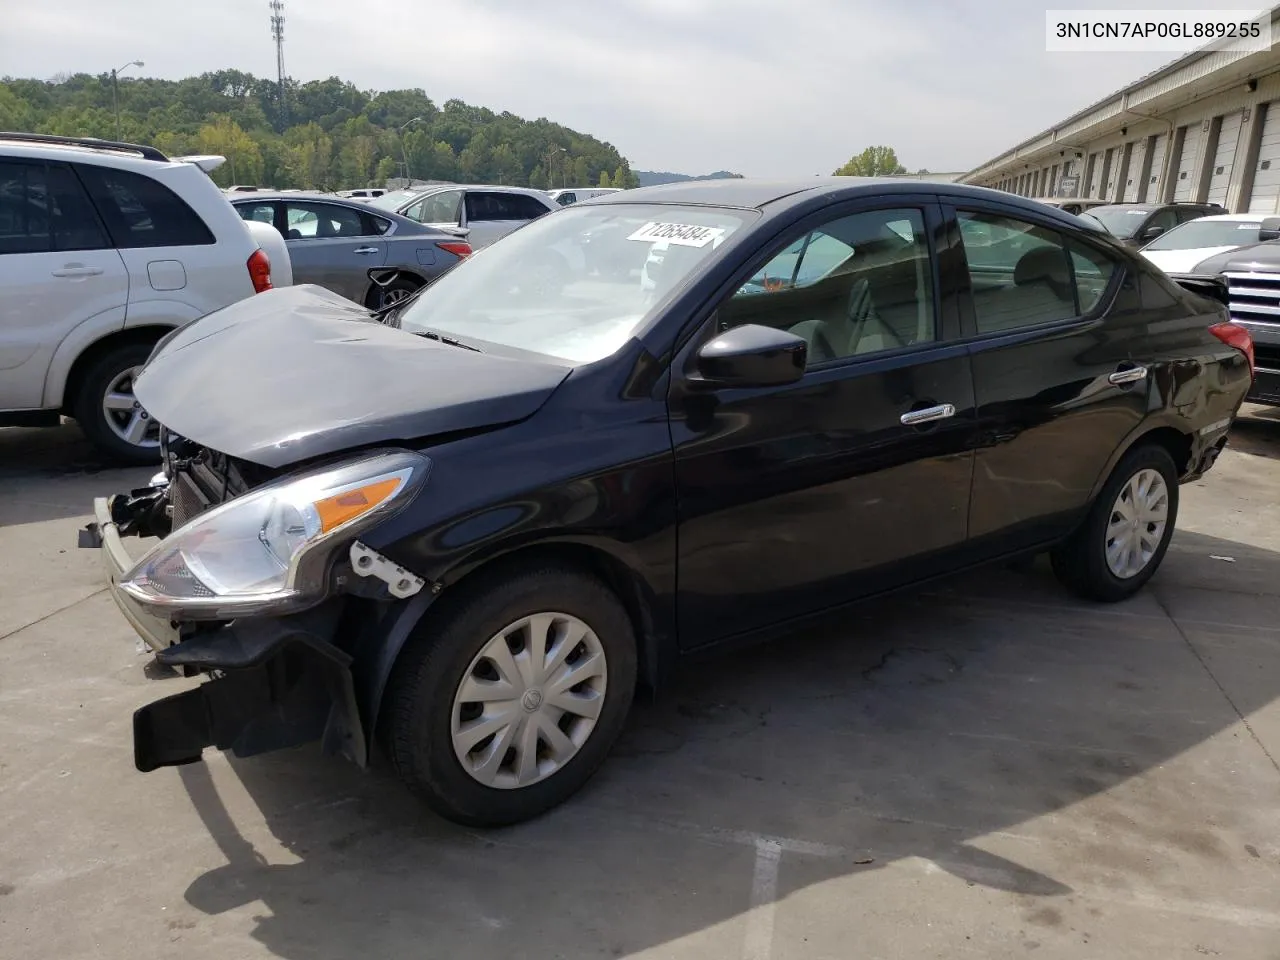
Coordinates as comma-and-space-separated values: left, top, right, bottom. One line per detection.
120, 451, 430, 620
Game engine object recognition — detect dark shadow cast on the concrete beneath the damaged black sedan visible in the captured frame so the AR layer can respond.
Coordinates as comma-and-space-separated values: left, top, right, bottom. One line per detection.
170, 531, 1280, 960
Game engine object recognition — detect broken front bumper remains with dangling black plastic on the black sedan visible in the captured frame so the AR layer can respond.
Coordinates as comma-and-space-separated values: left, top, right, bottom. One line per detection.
81, 498, 367, 772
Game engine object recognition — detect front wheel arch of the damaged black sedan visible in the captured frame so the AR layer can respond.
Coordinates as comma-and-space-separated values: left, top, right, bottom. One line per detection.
357, 540, 676, 736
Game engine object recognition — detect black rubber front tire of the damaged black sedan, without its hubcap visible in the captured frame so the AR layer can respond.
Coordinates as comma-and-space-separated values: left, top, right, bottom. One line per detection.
380, 564, 636, 827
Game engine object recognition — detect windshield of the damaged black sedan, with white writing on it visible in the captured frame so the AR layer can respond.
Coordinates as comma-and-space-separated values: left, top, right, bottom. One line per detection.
399, 204, 751, 364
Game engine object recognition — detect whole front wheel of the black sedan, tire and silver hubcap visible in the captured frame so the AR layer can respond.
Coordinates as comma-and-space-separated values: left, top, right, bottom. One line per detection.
384, 567, 636, 827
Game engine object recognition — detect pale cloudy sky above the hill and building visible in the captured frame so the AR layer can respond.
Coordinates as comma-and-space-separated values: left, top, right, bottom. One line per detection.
0, 0, 1269, 177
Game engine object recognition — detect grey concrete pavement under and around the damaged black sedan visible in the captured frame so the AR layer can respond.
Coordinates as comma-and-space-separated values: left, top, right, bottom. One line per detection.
0, 412, 1280, 960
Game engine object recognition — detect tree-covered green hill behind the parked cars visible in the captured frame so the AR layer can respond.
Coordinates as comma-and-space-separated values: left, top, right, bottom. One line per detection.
0, 70, 636, 189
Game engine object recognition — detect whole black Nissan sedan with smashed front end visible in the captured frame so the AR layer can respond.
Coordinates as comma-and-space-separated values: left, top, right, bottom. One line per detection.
83, 178, 1251, 826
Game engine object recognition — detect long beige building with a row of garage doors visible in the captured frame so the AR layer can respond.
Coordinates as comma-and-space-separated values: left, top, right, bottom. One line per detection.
961, 8, 1280, 214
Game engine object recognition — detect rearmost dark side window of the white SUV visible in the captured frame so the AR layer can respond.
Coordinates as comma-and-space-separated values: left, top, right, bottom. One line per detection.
79, 166, 216, 248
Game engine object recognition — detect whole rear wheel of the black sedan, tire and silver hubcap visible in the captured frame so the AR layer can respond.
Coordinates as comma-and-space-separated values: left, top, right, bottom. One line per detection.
1051, 445, 1178, 603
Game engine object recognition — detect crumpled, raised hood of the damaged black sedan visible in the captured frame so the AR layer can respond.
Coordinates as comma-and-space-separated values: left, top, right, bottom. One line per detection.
134, 284, 570, 467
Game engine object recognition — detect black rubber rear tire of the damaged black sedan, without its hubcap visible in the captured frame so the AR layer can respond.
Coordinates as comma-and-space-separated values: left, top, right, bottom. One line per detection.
1050, 444, 1178, 603
